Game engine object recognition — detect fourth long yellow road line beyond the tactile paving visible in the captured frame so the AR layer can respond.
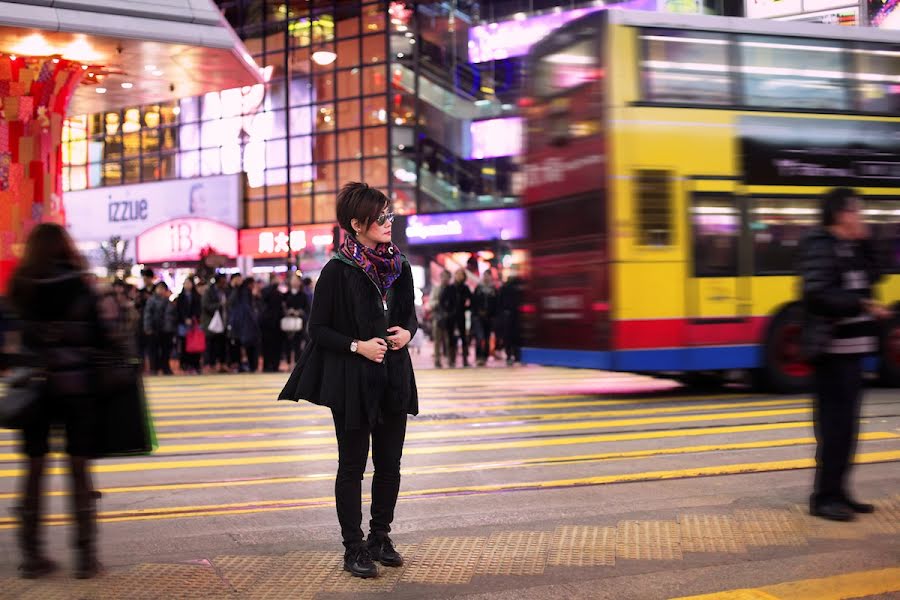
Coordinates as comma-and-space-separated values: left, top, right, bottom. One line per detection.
0, 408, 811, 461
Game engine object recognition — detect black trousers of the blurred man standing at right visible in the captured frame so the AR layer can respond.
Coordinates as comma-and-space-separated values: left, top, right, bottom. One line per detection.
811, 355, 863, 504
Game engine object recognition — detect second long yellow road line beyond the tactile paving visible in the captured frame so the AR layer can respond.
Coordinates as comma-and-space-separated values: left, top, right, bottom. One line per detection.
0, 432, 900, 500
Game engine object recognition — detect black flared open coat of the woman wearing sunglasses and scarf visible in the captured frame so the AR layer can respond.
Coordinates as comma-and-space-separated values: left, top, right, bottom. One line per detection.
278, 257, 419, 429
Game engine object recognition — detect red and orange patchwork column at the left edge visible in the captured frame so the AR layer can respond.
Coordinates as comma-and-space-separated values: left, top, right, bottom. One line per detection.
0, 54, 84, 294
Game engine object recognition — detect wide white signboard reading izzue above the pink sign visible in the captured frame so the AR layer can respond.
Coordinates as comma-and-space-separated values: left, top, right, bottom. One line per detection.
63, 175, 241, 242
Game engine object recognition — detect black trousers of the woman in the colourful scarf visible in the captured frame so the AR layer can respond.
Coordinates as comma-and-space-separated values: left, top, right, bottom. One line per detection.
333, 413, 406, 549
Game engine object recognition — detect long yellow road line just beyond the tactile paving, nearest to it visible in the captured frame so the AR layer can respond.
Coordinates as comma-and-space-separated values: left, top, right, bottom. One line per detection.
0, 450, 900, 529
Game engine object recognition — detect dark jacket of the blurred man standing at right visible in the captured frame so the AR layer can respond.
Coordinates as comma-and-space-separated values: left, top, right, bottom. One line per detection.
799, 229, 882, 360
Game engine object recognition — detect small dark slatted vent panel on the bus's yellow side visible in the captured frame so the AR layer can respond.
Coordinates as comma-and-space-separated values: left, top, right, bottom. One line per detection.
634, 169, 673, 246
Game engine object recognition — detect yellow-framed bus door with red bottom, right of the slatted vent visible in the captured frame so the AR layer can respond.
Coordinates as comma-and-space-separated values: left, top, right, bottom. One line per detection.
685, 188, 753, 346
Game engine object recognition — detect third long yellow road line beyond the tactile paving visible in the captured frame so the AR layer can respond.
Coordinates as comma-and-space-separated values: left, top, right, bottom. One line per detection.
0, 421, 828, 478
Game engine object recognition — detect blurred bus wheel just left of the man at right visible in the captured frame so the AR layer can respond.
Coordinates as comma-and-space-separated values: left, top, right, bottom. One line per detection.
761, 302, 812, 394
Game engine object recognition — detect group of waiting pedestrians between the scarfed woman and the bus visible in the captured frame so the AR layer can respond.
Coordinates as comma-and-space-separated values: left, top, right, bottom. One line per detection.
428, 269, 522, 369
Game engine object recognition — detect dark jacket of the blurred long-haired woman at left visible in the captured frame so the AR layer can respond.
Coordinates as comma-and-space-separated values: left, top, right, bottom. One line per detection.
11, 265, 111, 398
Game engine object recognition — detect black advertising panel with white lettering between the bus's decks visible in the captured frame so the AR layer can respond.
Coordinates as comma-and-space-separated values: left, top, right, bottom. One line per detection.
738, 116, 900, 187
